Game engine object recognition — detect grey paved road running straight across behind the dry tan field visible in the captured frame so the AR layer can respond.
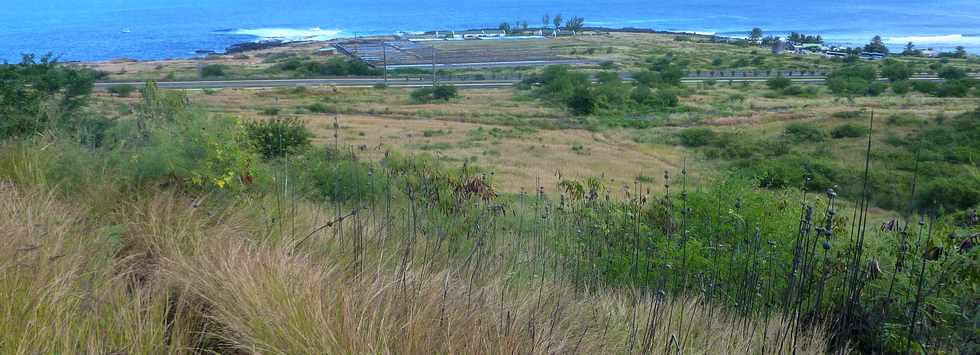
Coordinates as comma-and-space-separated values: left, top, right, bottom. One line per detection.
95, 76, 960, 90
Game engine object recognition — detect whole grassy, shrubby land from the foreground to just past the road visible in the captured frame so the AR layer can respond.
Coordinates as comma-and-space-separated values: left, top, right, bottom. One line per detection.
7, 34, 980, 354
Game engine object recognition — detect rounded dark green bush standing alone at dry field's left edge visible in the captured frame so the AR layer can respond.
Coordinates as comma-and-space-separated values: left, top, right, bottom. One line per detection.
245, 118, 313, 159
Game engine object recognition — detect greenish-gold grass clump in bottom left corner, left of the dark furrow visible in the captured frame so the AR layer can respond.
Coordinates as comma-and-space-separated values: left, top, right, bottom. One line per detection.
0, 183, 200, 354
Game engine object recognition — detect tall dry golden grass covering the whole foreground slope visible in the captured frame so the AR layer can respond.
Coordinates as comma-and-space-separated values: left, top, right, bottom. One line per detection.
0, 181, 844, 354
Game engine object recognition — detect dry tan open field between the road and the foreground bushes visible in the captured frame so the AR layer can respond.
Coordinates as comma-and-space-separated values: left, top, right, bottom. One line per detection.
90, 74, 977, 200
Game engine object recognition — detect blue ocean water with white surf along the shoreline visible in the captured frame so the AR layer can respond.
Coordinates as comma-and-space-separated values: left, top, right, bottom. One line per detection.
0, 0, 980, 62
